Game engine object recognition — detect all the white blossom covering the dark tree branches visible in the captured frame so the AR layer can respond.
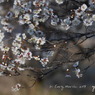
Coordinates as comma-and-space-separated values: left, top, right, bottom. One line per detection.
0, 0, 95, 85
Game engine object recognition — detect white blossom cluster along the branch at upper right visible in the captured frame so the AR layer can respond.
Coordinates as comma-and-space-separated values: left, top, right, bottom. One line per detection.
51, 0, 95, 30
